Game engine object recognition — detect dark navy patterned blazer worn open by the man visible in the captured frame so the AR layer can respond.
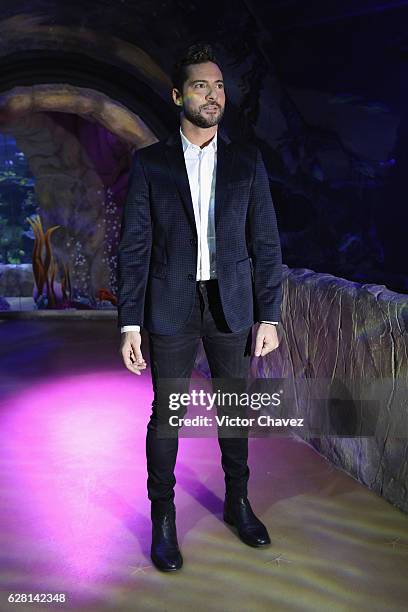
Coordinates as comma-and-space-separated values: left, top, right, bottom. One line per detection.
118, 129, 282, 335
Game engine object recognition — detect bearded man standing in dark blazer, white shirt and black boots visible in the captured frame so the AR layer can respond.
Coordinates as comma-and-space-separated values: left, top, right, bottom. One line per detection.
118, 44, 282, 571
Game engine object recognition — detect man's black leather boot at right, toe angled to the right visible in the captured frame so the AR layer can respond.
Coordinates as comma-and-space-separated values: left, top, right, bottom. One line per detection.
224, 495, 271, 547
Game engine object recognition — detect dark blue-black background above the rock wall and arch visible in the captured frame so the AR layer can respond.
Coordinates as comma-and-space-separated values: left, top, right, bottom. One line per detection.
0, 0, 408, 293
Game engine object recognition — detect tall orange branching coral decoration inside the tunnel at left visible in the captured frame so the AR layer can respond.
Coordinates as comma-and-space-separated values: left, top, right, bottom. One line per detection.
27, 215, 71, 308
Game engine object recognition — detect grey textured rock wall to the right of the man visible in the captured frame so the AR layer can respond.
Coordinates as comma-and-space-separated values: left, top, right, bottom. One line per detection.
197, 266, 408, 512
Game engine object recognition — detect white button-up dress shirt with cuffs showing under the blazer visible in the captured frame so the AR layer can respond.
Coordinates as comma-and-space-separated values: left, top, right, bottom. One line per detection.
121, 127, 278, 332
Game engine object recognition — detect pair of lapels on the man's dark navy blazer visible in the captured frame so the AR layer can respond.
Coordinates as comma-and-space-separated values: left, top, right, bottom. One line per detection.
165, 129, 233, 237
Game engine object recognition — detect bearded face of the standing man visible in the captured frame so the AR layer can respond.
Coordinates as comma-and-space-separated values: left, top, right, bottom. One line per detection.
173, 62, 225, 128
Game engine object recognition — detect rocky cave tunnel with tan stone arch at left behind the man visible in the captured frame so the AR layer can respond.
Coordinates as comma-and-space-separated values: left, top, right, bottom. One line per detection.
1, 46, 171, 309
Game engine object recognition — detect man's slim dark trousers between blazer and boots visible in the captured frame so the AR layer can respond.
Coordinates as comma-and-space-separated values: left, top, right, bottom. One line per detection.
146, 280, 252, 507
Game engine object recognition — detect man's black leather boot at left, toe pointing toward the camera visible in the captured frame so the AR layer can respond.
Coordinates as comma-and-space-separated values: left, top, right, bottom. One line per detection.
150, 503, 183, 572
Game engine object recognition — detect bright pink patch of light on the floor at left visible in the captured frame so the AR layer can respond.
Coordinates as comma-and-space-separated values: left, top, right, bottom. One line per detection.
0, 371, 152, 581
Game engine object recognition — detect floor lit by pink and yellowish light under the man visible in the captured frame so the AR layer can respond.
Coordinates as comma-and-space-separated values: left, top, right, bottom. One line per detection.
0, 320, 408, 612
